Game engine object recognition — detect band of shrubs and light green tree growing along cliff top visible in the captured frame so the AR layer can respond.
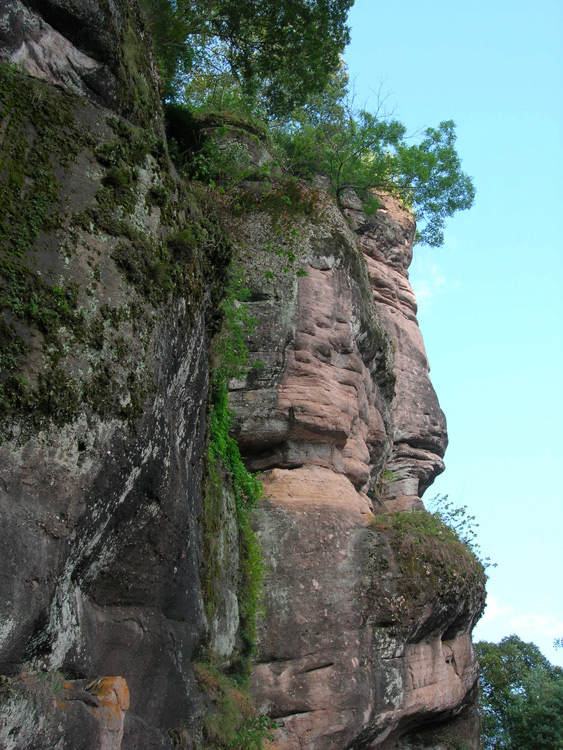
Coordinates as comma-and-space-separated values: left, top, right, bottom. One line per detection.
161, 72, 475, 246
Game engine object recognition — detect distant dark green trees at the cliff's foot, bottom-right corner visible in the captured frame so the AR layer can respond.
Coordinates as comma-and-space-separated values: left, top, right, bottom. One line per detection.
476, 635, 563, 750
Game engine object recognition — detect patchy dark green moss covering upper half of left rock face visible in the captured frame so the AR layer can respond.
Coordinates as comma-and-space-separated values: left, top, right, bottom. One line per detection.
0, 63, 231, 440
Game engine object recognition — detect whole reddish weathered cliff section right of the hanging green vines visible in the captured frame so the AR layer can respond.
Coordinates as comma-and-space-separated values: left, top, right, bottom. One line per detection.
231, 191, 483, 750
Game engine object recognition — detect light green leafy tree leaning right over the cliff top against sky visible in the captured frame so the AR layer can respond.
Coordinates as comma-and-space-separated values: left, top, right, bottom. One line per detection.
278, 69, 475, 246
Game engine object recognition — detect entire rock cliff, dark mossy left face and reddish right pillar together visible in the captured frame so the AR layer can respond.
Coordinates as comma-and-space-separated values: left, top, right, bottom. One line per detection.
0, 0, 484, 750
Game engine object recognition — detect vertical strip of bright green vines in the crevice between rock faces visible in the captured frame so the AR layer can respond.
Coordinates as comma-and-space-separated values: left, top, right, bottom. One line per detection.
202, 263, 275, 750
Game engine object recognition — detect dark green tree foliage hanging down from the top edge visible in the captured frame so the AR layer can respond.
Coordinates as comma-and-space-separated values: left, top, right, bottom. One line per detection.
142, 0, 354, 114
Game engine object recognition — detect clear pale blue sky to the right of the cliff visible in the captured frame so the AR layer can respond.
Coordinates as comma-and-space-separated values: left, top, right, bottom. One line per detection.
345, 0, 563, 665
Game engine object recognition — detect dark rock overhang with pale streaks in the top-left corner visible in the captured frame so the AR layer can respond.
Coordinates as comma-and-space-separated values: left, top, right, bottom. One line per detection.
0, 0, 161, 127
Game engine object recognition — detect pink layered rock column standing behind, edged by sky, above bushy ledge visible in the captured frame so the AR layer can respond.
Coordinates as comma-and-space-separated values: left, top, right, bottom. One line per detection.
352, 195, 448, 505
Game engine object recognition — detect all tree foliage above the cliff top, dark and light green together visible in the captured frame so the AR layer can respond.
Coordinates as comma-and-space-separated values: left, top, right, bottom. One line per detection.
142, 0, 475, 250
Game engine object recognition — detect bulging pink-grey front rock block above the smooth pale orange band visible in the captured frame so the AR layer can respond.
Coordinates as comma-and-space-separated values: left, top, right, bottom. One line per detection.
232, 198, 394, 491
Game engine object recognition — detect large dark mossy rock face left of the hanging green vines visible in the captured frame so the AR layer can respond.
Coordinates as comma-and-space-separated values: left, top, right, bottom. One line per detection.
0, 51, 209, 750
